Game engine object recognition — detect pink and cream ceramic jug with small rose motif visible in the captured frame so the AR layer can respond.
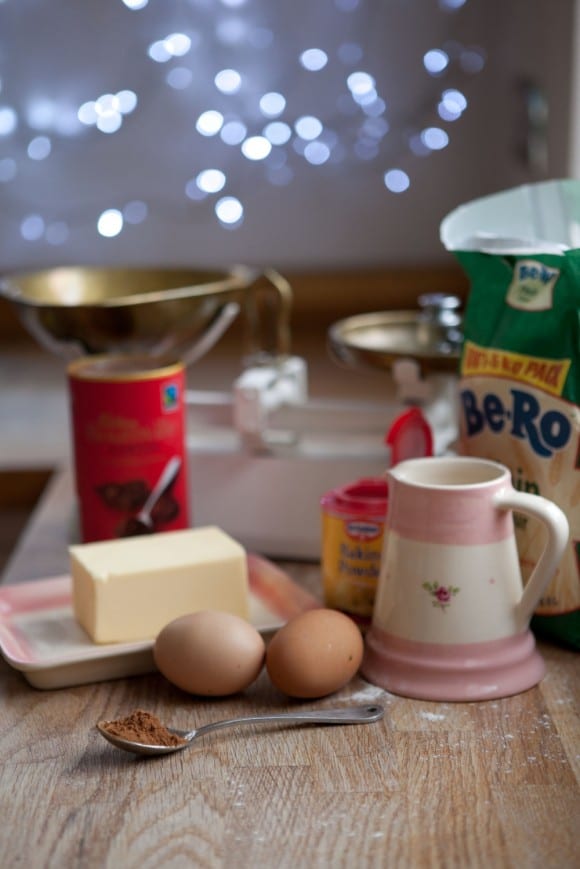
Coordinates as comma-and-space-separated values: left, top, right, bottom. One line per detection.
362, 457, 569, 700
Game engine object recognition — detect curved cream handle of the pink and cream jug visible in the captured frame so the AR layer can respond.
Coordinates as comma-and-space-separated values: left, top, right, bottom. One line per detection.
494, 489, 570, 630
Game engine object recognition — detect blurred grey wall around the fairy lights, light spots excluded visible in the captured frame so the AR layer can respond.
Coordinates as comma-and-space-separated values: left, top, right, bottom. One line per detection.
0, 0, 580, 271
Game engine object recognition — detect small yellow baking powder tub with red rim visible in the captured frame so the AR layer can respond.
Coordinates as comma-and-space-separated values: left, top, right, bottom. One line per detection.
320, 477, 387, 626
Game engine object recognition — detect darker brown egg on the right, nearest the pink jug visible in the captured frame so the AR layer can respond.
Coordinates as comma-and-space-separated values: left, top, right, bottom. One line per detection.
266, 609, 363, 698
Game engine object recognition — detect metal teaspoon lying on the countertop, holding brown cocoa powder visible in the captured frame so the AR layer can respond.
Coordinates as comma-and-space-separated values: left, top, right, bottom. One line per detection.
97, 706, 385, 755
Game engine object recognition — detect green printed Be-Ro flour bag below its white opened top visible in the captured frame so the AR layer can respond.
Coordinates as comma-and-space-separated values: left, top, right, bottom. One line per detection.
456, 250, 580, 648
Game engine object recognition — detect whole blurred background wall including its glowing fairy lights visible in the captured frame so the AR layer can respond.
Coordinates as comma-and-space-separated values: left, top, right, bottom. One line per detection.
0, 0, 575, 271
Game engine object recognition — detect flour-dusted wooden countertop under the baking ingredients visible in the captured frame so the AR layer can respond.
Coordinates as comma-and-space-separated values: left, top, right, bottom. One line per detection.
0, 477, 580, 869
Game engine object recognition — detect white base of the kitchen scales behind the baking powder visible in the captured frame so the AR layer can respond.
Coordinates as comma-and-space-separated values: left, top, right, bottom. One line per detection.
187, 357, 457, 560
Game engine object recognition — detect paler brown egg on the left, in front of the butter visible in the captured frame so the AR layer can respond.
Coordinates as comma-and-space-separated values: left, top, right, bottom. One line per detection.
153, 610, 266, 697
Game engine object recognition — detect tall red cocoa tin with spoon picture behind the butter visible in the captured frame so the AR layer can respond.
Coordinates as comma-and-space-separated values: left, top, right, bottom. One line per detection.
68, 356, 190, 542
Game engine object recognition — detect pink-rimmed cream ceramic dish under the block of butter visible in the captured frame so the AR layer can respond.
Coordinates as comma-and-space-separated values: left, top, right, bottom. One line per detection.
0, 555, 320, 689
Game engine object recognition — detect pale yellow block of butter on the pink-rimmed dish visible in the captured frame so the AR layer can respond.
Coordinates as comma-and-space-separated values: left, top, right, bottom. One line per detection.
69, 526, 249, 643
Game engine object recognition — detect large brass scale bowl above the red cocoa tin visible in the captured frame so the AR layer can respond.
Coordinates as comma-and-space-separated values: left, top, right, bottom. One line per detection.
0, 266, 290, 362
